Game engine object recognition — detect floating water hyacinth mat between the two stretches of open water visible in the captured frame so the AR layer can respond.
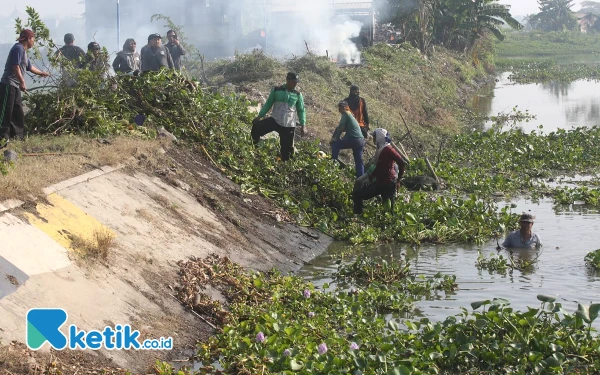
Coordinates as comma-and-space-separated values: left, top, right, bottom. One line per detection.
438, 117, 600, 195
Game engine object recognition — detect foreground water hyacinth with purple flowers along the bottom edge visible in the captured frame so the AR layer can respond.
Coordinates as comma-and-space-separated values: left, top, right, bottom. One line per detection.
161, 261, 600, 375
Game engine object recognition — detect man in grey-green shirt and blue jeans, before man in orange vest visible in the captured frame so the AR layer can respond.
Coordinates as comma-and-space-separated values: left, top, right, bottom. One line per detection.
329, 100, 365, 178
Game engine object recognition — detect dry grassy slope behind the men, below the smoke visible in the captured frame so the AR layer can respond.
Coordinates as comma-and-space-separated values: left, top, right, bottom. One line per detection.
208, 44, 486, 154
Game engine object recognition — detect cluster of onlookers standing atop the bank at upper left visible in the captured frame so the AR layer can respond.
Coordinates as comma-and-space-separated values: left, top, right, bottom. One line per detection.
56, 30, 185, 74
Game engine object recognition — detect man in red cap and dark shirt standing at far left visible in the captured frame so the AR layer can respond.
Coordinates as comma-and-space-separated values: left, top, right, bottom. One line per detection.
0, 29, 50, 147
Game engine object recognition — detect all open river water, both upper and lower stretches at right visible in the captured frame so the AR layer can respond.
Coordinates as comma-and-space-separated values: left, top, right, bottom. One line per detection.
299, 69, 600, 323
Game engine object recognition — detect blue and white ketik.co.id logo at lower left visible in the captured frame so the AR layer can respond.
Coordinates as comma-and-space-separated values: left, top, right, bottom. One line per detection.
26, 309, 173, 350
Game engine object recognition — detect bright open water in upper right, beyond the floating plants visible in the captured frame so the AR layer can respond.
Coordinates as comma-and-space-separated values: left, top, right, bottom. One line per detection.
471, 72, 600, 133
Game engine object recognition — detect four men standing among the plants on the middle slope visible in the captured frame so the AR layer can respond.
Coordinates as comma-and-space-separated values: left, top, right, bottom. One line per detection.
251, 72, 407, 214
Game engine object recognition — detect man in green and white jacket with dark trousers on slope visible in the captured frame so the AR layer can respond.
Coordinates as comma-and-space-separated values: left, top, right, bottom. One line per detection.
250, 72, 306, 161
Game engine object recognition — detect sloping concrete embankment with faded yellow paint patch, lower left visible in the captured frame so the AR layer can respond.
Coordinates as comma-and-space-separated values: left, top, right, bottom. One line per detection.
0, 147, 331, 373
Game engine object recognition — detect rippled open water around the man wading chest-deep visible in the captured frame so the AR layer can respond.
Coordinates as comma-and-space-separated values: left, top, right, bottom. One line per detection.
299, 200, 600, 323
